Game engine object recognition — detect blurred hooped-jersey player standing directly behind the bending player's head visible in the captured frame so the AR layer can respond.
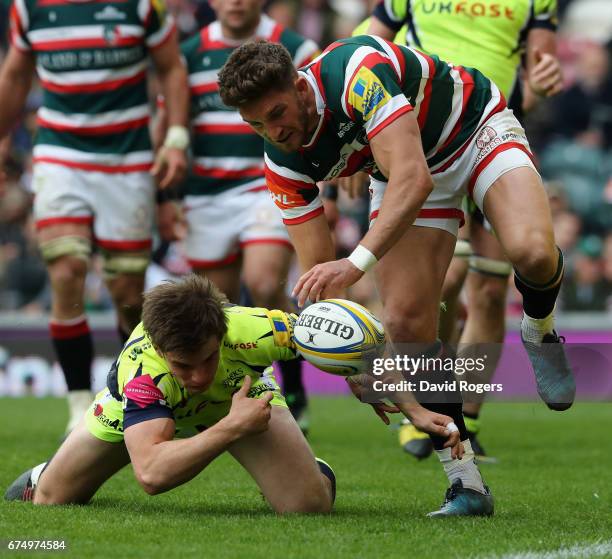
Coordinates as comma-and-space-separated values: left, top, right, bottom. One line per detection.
158, 0, 319, 431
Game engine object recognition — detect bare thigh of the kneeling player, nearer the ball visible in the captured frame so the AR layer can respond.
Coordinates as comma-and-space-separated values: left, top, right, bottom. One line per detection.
229, 406, 332, 512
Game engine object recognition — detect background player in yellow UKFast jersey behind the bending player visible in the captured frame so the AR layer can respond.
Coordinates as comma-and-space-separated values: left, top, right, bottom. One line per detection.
356, 0, 562, 459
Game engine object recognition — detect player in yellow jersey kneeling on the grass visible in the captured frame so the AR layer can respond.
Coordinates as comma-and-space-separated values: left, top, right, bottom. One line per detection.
5, 275, 335, 513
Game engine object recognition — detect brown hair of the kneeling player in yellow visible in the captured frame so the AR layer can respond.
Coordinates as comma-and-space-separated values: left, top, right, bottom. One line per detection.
142, 274, 227, 355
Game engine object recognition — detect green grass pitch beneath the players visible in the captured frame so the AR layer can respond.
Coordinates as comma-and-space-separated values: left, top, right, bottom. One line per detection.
0, 398, 612, 559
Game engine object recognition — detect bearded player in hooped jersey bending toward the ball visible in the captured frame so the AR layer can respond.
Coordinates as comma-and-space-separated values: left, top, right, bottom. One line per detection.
219, 36, 575, 516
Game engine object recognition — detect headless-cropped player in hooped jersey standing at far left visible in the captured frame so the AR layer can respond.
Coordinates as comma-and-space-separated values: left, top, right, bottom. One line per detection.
0, 0, 189, 431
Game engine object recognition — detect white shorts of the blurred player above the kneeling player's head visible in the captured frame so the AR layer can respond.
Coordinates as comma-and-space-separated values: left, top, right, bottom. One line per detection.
184, 187, 292, 269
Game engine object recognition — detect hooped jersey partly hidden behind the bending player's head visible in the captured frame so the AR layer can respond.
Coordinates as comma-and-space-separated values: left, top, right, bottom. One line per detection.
181, 14, 320, 196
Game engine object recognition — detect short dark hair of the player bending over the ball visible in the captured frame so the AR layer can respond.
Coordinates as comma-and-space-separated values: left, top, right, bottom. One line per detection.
219, 39, 297, 107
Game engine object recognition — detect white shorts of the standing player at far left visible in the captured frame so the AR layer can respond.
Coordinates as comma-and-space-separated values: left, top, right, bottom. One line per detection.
32, 163, 155, 251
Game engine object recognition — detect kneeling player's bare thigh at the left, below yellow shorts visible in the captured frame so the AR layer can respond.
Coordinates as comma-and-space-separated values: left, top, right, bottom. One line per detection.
34, 421, 130, 504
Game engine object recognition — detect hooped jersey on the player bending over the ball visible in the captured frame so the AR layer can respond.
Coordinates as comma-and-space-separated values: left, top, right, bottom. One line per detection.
265, 35, 506, 224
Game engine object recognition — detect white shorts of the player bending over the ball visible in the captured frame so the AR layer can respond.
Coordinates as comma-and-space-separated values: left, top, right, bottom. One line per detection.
370, 109, 537, 236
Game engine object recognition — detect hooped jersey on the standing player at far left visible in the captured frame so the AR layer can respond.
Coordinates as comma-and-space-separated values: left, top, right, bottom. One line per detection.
11, 0, 174, 173
